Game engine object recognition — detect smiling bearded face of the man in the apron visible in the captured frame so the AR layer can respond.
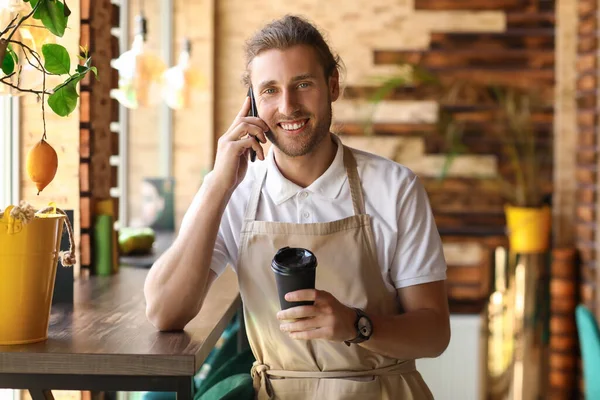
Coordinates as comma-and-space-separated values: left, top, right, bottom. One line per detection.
250, 46, 339, 157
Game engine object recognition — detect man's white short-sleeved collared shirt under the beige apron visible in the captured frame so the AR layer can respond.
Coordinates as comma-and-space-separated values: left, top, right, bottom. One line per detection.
182, 135, 446, 291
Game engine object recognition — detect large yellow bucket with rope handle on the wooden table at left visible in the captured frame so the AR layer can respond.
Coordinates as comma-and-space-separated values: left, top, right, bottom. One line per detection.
0, 206, 73, 345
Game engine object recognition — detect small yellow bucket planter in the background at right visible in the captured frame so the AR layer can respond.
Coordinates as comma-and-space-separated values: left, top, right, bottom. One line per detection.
505, 206, 551, 254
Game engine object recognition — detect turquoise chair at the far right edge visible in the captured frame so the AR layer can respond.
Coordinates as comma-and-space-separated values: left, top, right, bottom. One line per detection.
575, 304, 600, 400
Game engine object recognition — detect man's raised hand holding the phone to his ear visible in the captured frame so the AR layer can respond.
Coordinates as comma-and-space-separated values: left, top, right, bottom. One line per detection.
213, 97, 269, 197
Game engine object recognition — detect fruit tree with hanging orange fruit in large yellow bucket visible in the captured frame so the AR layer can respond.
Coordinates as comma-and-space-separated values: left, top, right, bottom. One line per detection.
0, 0, 97, 345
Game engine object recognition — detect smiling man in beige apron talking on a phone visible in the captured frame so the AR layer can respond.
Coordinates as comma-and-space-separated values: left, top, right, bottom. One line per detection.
145, 16, 450, 399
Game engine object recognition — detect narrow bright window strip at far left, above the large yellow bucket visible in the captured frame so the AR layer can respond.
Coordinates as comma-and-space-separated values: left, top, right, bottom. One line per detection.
0, 96, 19, 208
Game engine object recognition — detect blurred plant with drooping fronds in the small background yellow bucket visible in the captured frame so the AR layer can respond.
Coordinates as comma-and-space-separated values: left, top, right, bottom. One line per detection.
365, 64, 552, 254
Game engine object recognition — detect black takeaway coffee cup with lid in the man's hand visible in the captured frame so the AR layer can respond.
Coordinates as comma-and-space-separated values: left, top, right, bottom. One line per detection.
271, 247, 317, 310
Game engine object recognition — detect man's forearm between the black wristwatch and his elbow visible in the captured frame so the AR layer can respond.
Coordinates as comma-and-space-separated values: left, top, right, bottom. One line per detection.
359, 309, 450, 360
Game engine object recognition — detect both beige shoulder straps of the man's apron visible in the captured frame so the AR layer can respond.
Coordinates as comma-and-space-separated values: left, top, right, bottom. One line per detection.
244, 145, 365, 221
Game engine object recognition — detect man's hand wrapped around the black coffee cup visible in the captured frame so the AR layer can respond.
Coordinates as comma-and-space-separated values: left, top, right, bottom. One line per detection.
277, 289, 356, 342
